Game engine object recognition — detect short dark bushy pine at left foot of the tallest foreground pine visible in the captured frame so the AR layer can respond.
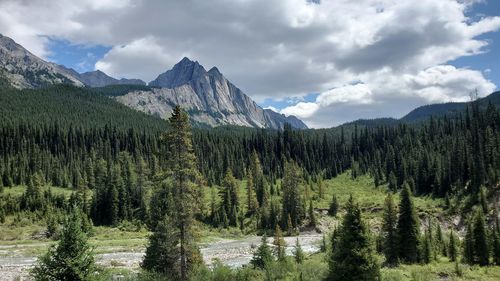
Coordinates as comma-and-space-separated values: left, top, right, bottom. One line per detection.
141, 217, 179, 278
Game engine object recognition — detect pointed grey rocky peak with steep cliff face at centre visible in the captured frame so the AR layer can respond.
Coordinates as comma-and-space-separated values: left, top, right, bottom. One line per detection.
117, 58, 307, 129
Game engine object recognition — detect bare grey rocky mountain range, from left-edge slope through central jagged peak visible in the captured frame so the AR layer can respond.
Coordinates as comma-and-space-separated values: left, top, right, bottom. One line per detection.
0, 35, 307, 129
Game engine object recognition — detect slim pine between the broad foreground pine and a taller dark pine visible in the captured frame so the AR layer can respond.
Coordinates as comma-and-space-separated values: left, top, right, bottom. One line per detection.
382, 193, 398, 265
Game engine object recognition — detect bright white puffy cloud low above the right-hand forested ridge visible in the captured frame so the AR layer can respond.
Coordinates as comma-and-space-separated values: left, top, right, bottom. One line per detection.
280, 65, 495, 127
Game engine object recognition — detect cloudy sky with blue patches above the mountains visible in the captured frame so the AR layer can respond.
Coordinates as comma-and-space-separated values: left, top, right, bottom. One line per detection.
0, 0, 500, 128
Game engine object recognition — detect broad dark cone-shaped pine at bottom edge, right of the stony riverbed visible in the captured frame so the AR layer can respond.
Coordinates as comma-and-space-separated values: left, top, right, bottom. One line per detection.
326, 196, 380, 281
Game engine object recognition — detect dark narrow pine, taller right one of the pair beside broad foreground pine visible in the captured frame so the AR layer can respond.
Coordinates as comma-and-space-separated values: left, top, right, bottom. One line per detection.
397, 185, 420, 263
